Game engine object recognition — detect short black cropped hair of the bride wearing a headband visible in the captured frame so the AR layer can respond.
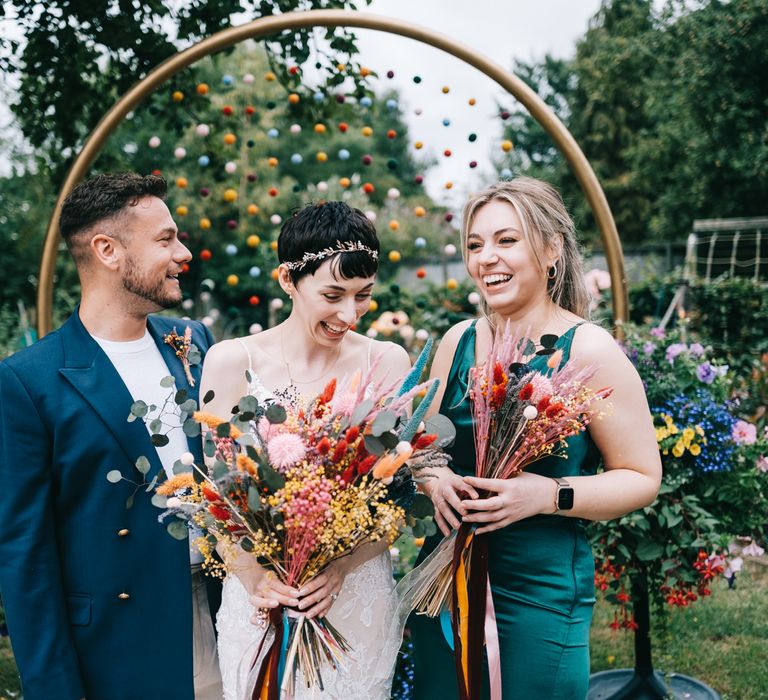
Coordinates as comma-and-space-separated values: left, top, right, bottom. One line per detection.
277, 202, 379, 284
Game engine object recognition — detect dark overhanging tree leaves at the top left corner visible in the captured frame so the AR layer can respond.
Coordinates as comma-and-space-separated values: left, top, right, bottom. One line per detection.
0, 0, 370, 180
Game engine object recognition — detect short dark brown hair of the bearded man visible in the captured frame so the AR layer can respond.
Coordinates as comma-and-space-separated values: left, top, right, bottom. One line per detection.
59, 173, 168, 262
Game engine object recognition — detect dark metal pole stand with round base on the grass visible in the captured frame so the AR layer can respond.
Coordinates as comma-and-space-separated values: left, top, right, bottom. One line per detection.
587, 570, 720, 700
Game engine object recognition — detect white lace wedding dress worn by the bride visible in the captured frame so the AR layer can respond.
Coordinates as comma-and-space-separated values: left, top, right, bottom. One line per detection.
217, 344, 400, 700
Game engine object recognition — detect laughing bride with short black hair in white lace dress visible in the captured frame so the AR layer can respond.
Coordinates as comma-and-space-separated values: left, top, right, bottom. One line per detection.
200, 202, 410, 700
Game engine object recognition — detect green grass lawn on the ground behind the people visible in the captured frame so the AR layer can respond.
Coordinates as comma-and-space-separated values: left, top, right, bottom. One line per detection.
0, 556, 768, 700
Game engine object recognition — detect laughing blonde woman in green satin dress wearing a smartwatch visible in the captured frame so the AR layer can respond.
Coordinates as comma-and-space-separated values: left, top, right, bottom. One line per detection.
411, 178, 661, 700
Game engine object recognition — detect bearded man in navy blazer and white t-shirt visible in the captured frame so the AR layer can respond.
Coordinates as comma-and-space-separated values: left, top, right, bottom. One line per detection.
0, 173, 221, 700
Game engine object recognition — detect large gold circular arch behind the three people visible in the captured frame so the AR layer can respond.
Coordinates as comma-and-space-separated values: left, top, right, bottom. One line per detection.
37, 10, 629, 337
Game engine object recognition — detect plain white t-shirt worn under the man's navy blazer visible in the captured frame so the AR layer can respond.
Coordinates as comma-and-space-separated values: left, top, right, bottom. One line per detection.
91, 330, 202, 564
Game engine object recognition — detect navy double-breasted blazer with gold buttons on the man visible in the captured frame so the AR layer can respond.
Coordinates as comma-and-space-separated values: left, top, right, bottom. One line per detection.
0, 309, 219, 700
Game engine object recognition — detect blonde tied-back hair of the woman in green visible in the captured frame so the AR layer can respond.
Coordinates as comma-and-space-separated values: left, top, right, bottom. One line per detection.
461, 177, 589, 323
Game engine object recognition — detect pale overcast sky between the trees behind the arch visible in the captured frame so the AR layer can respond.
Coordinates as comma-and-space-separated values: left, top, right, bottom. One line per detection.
357, 0, 600, 206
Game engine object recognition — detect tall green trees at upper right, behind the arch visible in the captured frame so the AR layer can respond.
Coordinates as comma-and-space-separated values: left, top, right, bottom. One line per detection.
500, 0, 768, 242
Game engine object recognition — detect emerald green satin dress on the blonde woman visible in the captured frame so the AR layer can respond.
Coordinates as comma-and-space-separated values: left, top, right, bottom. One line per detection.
409, 323, 599, 700
